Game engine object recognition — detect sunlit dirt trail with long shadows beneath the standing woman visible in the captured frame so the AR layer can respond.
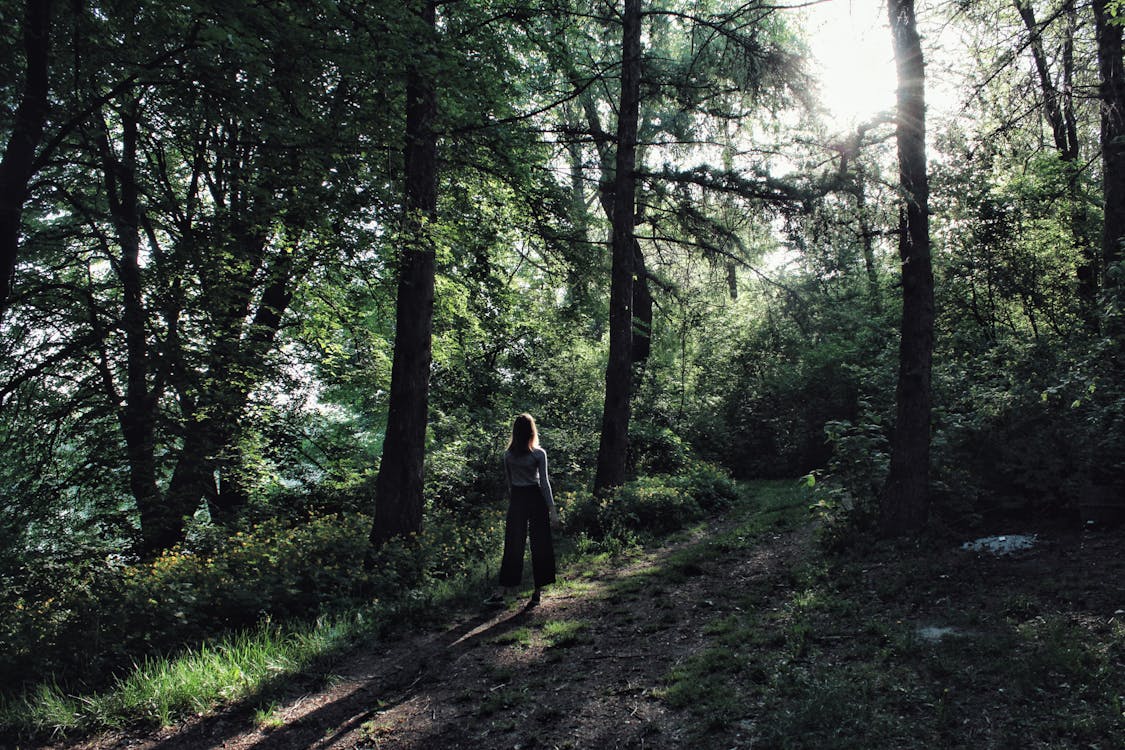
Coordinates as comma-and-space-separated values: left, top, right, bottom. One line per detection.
54, 522, 810, 750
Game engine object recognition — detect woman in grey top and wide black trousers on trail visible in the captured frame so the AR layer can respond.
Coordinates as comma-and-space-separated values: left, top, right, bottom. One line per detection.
487, 414, 559, 607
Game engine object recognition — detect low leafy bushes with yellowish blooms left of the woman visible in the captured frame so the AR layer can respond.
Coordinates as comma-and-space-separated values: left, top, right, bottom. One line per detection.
0, 508, 502, 687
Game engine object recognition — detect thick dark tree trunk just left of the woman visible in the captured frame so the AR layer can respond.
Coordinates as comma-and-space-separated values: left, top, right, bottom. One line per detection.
371, 0, 438, 548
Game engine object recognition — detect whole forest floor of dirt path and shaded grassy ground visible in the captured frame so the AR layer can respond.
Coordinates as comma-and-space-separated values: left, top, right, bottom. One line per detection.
39, 488, 1125, 750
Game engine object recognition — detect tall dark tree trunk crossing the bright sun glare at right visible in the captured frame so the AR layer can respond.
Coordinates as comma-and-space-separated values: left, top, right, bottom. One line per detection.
880, 0, 934, 535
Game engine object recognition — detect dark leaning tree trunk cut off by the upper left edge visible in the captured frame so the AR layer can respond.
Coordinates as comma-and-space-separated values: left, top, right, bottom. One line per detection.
0, 0, 51, 316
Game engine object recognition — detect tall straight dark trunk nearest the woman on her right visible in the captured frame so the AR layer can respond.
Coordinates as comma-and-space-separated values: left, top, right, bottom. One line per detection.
594, 0, 641, 493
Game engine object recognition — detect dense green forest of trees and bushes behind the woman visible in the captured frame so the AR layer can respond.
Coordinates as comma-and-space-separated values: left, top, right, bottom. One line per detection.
0, 0, 1125, 737
